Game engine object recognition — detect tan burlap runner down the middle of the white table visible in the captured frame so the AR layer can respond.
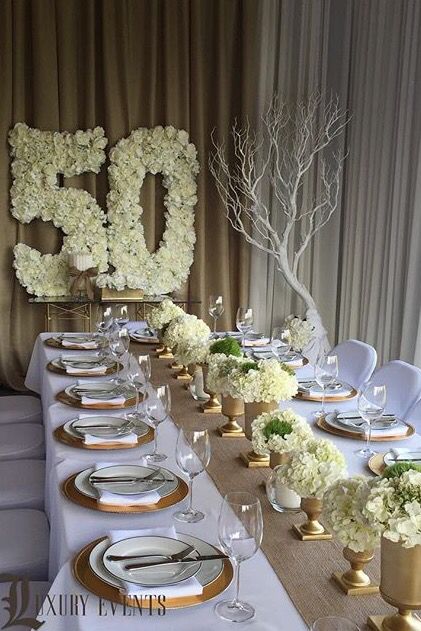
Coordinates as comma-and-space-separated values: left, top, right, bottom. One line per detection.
145, 347, 393, 631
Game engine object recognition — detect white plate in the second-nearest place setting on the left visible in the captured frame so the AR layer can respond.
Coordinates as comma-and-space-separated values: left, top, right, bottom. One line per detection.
89, 465, 167, 495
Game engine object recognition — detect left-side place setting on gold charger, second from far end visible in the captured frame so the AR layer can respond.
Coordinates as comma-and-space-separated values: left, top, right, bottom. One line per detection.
47, 354, 123, 377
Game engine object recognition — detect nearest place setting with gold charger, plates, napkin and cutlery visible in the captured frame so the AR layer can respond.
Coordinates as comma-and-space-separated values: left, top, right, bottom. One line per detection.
73, 528, 233, 609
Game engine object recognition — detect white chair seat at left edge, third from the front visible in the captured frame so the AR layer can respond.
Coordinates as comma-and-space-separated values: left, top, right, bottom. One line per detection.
0, 423, 44, 460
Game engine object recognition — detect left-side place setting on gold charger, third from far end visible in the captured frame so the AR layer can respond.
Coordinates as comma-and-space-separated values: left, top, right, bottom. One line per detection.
56, 380, 138, 410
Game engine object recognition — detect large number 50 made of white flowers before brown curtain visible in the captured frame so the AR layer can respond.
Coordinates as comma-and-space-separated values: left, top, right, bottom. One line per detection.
9, 123, 199, 296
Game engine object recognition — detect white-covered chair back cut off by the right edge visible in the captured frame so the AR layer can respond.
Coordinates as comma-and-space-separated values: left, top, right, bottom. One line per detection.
371, 359, 421, 419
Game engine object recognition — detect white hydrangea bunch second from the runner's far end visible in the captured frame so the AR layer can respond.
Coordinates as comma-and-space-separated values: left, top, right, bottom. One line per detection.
163, 312, 210, 366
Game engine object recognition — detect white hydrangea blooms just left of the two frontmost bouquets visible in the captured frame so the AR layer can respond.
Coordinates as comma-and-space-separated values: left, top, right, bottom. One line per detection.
278, 439, 346, 499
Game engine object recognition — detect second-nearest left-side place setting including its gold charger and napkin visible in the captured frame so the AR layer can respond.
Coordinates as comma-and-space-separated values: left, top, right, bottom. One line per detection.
62, 463, 188, 513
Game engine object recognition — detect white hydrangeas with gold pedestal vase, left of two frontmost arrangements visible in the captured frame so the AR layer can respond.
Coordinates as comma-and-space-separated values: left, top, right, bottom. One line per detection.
277, 439, 346, 541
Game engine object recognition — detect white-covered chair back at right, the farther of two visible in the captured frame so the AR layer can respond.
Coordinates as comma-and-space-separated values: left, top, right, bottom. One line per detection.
330, 340, 377, 390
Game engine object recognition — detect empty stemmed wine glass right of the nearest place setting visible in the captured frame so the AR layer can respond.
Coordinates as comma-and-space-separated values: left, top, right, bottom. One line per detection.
215, 492, 263, 622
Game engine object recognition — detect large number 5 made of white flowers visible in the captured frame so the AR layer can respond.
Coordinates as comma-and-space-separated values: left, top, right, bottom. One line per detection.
9, 123, 108, 296
